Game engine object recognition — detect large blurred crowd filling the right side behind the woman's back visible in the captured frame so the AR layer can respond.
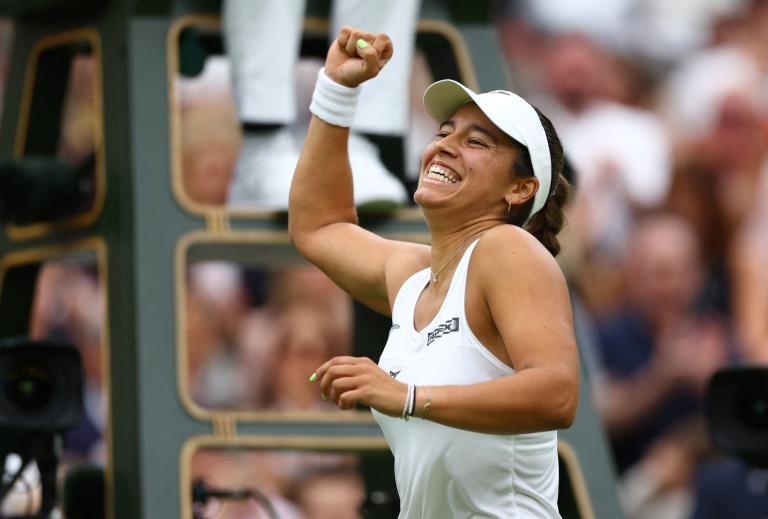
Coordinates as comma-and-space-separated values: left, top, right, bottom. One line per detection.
497, 0, 768, 519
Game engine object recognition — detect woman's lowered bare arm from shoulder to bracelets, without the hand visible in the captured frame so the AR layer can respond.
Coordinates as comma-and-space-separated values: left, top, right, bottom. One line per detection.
416, 230, 579, 434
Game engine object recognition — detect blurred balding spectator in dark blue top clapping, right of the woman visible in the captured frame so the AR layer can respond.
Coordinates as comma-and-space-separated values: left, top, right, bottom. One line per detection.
593, 212, 729, 518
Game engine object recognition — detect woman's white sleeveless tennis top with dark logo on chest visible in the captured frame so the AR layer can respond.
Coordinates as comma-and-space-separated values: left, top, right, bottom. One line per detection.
373, 241, 560, 519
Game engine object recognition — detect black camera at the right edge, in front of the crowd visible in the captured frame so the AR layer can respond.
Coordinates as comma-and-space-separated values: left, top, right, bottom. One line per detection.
705, 366, 768, 468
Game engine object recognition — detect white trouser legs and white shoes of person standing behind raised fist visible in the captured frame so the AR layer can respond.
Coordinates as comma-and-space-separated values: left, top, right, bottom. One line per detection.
223, 0, 420, 210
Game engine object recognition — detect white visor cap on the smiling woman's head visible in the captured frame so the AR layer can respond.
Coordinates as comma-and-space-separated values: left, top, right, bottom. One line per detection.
424, 79, 552, 221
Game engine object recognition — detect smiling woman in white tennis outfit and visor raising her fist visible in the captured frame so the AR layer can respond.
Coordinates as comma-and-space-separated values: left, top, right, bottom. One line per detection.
289, 27, 579, 519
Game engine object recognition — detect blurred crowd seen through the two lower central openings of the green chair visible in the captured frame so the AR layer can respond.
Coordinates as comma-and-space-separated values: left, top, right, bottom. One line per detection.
186, 261, 366, 519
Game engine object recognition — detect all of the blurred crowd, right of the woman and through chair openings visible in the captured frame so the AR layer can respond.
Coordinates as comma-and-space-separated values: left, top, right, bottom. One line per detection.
0, 0, 768, 519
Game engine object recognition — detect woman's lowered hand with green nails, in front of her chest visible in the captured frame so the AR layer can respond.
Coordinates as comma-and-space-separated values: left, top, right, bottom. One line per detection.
311, 357, 408, 416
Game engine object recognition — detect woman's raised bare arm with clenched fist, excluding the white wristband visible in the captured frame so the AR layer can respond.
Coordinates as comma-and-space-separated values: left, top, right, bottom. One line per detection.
288, 27, 428, 315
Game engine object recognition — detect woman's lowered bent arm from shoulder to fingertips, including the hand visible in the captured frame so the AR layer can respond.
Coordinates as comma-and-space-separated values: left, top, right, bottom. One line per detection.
317, 229, 579, 434
